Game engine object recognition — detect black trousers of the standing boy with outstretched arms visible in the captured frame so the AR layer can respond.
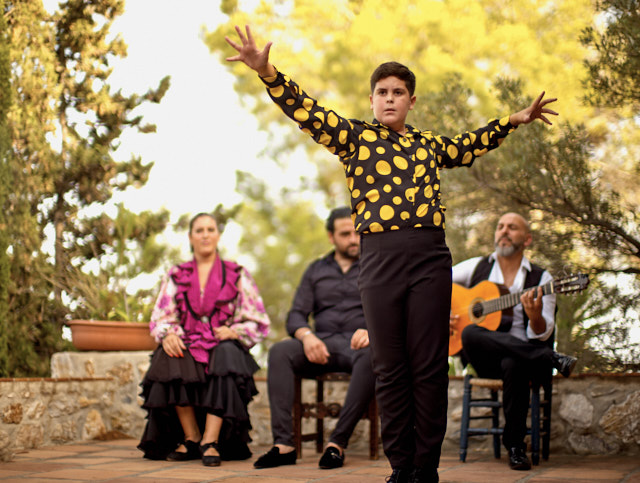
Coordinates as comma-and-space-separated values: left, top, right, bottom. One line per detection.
358, 229, 451, 468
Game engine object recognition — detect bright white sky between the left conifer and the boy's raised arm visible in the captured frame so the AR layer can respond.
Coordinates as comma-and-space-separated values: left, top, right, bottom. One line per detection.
44, 0, 269, 260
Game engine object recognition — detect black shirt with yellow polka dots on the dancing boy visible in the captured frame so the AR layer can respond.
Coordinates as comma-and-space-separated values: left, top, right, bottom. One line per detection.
262, 72, 516, 233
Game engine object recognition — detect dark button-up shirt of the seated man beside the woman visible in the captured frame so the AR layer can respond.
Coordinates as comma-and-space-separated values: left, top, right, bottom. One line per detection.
287, 252, 367, 339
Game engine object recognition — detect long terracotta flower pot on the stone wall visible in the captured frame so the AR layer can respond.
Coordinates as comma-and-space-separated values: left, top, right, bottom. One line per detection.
67, 320, 158, 351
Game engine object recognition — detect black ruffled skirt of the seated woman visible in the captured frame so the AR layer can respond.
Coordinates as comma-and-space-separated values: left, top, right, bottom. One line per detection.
138, 341, 259, 460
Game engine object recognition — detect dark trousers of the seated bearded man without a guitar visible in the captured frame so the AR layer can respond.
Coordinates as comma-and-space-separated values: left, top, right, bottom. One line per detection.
267, 334, 375, 448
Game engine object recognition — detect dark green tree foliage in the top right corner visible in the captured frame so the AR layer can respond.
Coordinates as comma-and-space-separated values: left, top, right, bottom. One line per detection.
581, 0, 640, 108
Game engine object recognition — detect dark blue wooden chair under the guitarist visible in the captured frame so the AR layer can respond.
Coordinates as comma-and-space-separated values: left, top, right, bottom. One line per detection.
460, 373, 552, 465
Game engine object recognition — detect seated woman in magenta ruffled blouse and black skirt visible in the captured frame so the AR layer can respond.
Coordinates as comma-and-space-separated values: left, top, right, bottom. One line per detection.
138, 213, 269, 466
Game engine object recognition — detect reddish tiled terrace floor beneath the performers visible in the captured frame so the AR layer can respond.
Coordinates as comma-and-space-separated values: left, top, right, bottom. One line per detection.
0, 439, 640, 483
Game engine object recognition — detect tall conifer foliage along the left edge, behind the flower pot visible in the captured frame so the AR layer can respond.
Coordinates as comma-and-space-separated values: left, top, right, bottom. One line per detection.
0, 0, 169, 376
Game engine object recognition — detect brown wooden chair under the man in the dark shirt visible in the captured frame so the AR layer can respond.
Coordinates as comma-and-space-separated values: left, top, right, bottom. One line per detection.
293, 372, 380, 460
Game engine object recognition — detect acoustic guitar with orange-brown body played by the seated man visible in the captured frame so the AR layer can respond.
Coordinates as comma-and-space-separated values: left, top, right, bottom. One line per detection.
449, 273, 589, 356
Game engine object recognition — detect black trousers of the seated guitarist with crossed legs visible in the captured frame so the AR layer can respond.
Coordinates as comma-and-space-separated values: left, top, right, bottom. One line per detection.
462, 324, 553, 449
